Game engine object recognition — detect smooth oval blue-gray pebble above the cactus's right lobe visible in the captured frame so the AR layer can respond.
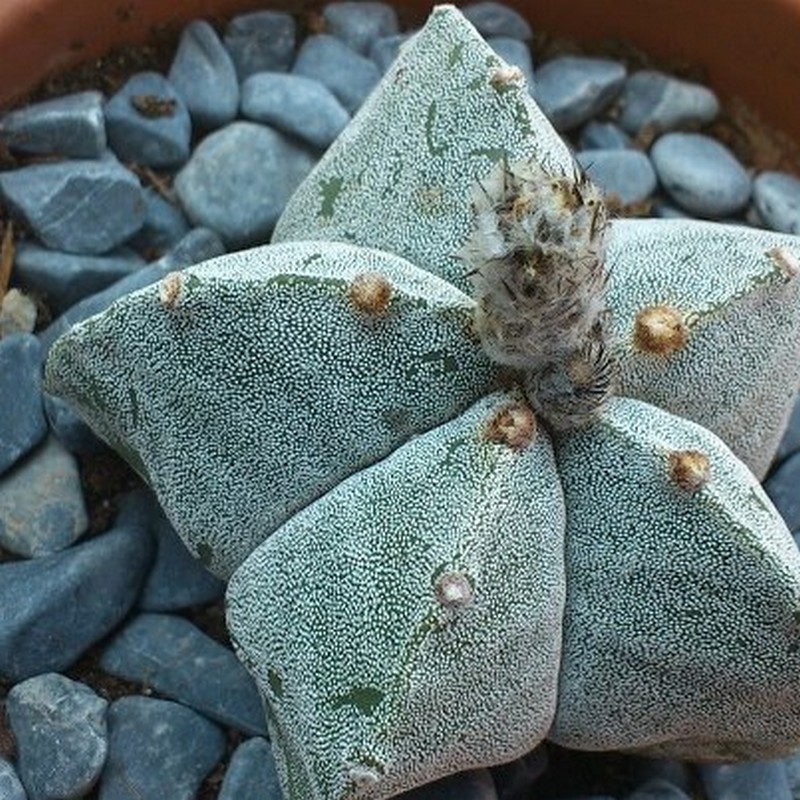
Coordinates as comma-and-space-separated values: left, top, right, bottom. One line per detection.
650, 133, 752, 219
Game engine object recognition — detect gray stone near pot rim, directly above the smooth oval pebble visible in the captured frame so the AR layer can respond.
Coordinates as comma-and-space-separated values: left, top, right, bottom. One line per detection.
619, 70, 719, 135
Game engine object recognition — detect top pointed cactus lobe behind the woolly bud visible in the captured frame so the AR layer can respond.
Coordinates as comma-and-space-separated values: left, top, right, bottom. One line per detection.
273, 6, 574, 289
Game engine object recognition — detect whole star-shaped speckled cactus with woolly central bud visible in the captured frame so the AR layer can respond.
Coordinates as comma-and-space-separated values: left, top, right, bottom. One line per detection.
45, 7, 800, 800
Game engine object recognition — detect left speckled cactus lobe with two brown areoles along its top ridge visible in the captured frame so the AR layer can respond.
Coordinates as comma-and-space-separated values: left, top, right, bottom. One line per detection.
46, 242, 494, 576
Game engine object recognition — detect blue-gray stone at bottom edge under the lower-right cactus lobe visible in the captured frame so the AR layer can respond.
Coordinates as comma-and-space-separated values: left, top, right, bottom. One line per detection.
699, 761, 792, 800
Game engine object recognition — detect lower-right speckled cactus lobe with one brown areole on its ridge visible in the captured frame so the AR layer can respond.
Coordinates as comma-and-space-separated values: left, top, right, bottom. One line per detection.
550, 399, 800, 760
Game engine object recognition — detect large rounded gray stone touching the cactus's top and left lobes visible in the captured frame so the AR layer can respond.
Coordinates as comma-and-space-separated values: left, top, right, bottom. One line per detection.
175, 120, 316, 248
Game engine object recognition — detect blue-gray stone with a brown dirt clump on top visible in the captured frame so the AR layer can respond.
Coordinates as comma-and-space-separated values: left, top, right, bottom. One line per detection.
106, 72, 192, 169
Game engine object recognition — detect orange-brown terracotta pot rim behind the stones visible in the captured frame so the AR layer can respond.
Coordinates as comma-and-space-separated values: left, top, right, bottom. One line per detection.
0, 0, 800, 141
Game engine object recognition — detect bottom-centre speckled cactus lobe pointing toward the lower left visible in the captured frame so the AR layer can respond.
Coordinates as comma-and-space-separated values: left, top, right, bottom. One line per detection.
227, 393, 564, 800
